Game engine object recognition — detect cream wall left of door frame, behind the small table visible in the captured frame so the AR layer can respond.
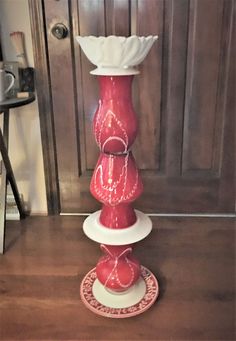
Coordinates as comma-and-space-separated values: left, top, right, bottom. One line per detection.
0, 0, 47, 214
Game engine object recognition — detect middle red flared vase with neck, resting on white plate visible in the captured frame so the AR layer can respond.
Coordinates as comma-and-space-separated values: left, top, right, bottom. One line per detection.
90, 152, 143, 228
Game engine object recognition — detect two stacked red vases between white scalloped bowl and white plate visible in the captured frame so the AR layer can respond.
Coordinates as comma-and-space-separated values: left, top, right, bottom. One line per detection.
90, 76, 143, 228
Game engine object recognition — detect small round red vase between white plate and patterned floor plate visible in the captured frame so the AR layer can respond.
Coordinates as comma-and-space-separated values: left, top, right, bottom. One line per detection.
96, 244, 141, 292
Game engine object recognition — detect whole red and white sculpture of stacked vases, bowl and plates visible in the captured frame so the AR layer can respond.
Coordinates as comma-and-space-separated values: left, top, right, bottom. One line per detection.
77, 36, 158, 318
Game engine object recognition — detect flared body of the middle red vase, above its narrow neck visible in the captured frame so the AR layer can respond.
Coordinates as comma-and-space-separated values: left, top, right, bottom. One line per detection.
90, 152, 143, 212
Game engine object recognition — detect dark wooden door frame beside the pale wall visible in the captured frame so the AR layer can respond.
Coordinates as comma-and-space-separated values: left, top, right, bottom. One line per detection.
28, 0, 60, 215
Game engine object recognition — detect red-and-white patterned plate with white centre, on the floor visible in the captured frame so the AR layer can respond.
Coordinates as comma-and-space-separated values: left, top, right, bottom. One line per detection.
80, 266, 159, 318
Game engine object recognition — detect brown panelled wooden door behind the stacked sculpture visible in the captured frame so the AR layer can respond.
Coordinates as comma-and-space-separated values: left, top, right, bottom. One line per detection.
37, 0, 235, 213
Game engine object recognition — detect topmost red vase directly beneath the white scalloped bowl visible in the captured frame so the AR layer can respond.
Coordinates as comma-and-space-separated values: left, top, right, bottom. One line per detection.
93, 76, 137, 153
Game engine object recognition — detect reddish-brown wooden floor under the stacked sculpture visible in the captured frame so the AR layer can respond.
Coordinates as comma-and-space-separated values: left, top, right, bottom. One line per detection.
0, 216, 236, 341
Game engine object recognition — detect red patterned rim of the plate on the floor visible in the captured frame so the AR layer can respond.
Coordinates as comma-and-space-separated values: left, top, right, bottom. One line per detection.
80, 265, 159, 318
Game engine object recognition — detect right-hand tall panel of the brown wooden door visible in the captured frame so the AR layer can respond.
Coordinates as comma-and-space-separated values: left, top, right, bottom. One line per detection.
183, 0, 230, 176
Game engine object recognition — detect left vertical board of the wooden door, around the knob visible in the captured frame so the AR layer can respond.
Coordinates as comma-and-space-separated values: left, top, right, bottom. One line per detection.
44, 1, 79, 202
